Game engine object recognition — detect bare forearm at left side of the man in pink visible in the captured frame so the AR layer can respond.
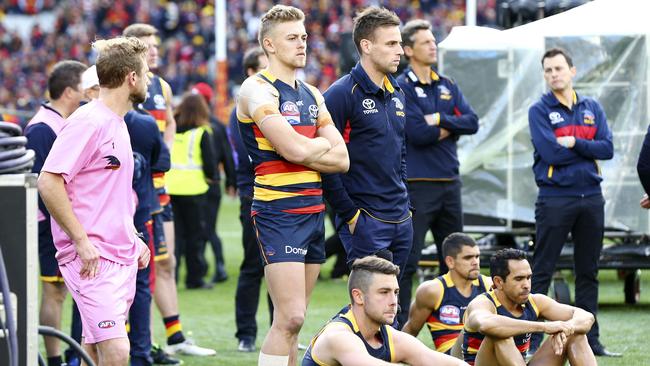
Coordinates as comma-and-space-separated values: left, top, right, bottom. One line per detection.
38, 172, 87, 243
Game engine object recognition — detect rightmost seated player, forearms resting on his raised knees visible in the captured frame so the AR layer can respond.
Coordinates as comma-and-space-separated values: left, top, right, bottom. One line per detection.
462, 248, 597, 366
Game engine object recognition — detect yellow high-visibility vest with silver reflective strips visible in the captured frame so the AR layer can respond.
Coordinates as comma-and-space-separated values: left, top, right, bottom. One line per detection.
165, 126, 210, 196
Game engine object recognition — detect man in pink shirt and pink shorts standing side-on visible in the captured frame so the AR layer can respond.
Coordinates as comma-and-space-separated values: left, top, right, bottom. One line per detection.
38, 38, 149, 366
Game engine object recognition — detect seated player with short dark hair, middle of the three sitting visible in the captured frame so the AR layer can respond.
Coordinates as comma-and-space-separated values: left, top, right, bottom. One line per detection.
402, 233, 492, 354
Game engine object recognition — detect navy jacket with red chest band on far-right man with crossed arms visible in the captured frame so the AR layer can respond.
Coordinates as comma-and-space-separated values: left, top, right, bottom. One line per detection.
528, 92, 614, 197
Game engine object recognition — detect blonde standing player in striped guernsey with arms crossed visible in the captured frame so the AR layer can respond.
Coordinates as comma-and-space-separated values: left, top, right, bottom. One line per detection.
237, 5, 349, 366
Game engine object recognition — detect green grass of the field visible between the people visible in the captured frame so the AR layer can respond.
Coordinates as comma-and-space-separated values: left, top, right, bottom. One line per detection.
54, 197, 650, 366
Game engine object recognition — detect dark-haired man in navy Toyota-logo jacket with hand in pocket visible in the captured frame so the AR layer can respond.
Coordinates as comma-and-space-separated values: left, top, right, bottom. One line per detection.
323, 7, 413, 278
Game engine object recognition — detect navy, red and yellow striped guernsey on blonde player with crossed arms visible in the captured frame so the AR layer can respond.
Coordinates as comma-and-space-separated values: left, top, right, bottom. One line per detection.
237, 70, 325, 215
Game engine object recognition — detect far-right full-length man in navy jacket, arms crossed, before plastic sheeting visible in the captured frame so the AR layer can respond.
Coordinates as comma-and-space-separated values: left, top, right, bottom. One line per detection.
528, 48, 614, 356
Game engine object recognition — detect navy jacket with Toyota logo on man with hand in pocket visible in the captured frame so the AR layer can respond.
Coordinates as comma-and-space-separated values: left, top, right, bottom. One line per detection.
322, 63, 410, 222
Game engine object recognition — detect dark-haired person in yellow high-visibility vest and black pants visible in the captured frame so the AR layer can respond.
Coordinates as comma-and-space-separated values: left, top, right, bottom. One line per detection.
166, 94, 216, 289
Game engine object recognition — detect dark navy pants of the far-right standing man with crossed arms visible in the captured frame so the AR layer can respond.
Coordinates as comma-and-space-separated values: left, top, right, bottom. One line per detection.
531, 194, 605, 344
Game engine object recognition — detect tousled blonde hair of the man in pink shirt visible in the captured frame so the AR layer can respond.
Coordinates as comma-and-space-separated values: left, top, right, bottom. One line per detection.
93, 37, 149, 89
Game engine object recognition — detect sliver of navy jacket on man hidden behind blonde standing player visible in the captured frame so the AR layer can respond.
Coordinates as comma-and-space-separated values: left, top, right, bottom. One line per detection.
228, 108, 255, 198
